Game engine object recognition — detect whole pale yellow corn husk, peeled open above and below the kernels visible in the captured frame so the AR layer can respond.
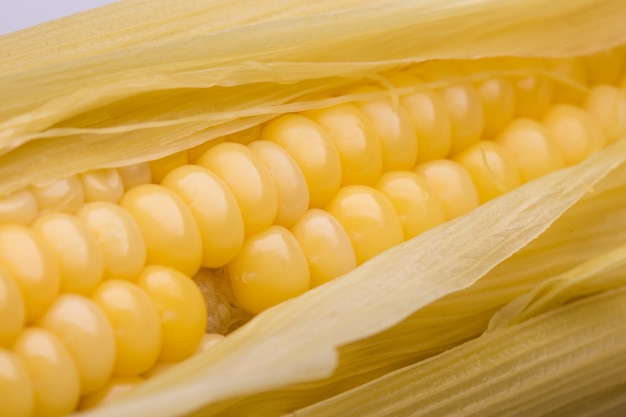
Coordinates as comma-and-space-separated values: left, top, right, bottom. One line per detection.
0, 0, 626, 416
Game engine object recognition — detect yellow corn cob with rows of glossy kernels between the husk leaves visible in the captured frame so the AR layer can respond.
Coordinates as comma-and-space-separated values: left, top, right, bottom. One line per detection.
0, 0, 626, 414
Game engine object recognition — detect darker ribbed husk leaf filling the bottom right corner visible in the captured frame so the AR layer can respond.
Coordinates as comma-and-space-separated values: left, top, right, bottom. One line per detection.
289, 287, 626, 417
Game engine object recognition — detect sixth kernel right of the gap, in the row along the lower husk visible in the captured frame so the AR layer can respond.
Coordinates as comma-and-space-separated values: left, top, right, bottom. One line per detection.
454, 140, 522, 203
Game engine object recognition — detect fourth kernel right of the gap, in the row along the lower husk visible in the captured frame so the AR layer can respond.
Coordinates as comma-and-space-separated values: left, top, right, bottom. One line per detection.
376, 171, 446, 240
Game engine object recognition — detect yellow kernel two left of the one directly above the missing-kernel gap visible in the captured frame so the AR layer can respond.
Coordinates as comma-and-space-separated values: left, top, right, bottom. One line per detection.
76, 202, 147, 280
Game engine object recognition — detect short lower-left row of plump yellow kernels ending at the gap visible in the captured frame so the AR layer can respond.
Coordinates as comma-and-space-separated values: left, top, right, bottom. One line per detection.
0, 266, 206, 416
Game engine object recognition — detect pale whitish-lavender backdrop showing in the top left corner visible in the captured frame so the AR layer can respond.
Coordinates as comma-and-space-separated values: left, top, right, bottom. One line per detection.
0, 0, 115, 35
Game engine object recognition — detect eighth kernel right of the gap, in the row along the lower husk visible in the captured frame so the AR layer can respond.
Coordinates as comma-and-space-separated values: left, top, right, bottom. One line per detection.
543, 104, 606, 166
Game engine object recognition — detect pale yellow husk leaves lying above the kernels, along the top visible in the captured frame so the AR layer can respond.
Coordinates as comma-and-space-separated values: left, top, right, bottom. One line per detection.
0, 0, 626, 194
